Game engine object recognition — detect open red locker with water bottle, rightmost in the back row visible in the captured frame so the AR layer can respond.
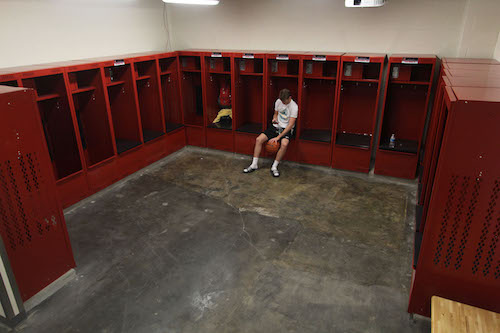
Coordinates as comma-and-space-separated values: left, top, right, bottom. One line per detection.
375, 54, 436, 179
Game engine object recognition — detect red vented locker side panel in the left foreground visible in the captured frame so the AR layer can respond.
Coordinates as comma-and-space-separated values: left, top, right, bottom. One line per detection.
0, 86, 75, 301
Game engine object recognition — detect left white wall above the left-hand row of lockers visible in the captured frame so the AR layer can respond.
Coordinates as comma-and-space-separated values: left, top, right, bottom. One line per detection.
0, 0, 166, 68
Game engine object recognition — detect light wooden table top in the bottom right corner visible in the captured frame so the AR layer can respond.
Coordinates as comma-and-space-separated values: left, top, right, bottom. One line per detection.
431, 296, 500, 333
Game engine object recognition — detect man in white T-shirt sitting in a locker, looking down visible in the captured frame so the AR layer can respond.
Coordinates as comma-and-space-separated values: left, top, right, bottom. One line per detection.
243, 89, 299, 177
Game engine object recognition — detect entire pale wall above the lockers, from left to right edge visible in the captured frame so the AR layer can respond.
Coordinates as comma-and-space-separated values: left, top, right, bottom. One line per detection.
0, 0, 500, 68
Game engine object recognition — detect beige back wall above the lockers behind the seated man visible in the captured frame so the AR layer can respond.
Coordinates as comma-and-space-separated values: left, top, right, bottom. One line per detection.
168, 0, 468, 56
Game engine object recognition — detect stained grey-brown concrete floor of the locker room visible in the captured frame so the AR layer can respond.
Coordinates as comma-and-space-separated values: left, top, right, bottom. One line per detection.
3, 148, 430, 333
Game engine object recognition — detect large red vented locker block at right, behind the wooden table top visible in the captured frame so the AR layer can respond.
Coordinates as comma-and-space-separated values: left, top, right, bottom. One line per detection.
408, 87, 500, 316
